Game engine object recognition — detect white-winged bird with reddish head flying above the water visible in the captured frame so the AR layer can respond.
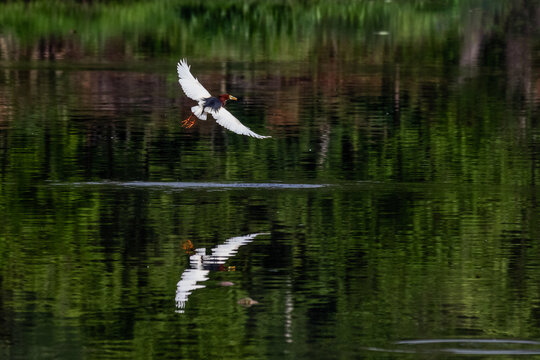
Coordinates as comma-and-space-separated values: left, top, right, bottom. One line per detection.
177, 59, 270, 139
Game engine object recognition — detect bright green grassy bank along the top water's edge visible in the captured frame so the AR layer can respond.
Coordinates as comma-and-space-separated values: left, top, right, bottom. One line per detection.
0, 0, 502, 58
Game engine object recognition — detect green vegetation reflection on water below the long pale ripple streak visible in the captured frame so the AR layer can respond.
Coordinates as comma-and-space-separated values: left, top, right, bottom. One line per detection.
0, 185, 540, 358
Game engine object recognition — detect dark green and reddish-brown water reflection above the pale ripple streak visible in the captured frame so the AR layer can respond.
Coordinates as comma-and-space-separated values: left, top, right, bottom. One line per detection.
0, 59, 540, 186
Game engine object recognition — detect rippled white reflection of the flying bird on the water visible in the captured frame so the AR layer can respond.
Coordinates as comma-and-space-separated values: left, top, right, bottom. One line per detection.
176, 233, 269, 313
